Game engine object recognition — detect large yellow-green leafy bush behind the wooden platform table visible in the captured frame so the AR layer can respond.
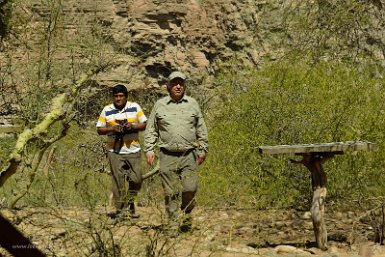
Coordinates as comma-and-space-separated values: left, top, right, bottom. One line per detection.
201, 61, 385, 208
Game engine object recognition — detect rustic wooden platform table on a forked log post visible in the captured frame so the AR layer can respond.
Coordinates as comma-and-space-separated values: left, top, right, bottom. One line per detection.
258, 141, 377, 250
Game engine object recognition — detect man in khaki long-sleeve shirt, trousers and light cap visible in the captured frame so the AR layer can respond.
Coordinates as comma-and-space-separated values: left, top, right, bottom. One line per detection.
144, 71, 208, 236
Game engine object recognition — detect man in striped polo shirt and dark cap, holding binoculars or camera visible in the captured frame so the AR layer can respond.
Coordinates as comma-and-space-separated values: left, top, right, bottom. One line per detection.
96, 84, 147, 218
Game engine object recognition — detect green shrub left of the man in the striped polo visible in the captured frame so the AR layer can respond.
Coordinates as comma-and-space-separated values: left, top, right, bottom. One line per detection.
0, 124, 110, 209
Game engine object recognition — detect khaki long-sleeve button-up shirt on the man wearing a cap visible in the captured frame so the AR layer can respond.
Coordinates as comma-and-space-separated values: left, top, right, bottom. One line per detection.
144, 95, 208, 153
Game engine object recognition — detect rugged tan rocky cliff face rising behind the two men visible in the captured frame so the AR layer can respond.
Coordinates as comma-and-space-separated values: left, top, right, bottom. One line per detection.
0, 0, 385, 89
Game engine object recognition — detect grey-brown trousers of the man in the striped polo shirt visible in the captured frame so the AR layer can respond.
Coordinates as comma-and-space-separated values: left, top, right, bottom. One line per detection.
108, 152, 142, 212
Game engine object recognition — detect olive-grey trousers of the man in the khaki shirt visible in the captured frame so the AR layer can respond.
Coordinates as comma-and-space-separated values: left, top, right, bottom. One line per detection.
159, 149, 198, 221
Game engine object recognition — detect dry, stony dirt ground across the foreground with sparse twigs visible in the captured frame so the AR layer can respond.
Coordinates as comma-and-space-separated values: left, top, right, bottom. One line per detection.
0, 206, 385, 257
